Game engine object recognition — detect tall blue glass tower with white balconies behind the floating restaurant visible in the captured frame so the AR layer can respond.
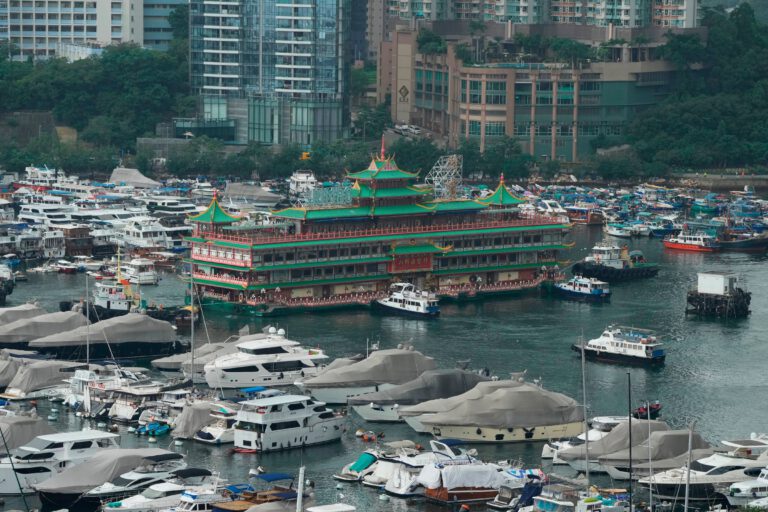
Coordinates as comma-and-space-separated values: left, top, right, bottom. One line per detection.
188, 0, 352, 145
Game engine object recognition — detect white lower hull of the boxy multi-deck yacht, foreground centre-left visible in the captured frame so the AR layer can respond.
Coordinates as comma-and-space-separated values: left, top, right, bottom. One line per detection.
235, 417, 345, 453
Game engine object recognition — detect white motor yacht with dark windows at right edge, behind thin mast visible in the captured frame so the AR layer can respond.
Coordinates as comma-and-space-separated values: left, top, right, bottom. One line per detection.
639, 449, 768, 502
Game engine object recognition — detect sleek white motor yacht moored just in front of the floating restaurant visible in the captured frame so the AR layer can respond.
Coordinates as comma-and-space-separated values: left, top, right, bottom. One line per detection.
204, 327, 328, 389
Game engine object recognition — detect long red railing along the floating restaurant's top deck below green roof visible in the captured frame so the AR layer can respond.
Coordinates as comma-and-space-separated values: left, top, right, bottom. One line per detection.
196, 215, 563, 245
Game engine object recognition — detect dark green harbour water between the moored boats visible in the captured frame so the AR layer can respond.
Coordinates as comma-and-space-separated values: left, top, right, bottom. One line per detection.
5, 226, 768, 511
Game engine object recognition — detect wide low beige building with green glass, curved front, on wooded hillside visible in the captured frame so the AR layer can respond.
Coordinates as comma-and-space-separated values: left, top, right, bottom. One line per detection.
378, 23, 700, 161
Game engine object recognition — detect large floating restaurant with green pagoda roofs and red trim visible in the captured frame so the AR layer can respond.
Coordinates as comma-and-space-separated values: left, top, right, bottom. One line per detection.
188, 154, 570, 315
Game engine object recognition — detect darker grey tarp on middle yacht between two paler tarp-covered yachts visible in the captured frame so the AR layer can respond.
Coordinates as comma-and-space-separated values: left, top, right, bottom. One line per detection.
347, 369, 488, 405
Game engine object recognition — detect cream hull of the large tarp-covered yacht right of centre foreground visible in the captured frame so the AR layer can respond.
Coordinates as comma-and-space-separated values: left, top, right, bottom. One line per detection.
432, 422, 584, 443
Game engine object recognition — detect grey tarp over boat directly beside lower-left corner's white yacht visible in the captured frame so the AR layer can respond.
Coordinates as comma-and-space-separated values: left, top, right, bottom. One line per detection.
34, 448, 172, 494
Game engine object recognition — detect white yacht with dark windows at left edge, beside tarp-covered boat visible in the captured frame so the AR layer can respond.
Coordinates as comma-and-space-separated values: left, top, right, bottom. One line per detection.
0, 430, 120, 495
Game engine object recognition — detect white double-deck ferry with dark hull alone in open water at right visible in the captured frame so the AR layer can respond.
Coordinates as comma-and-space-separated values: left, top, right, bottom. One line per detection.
571, 326, 667, 365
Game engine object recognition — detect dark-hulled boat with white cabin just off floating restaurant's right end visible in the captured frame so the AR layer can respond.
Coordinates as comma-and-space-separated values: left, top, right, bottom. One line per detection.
573, 243, 659, 282
